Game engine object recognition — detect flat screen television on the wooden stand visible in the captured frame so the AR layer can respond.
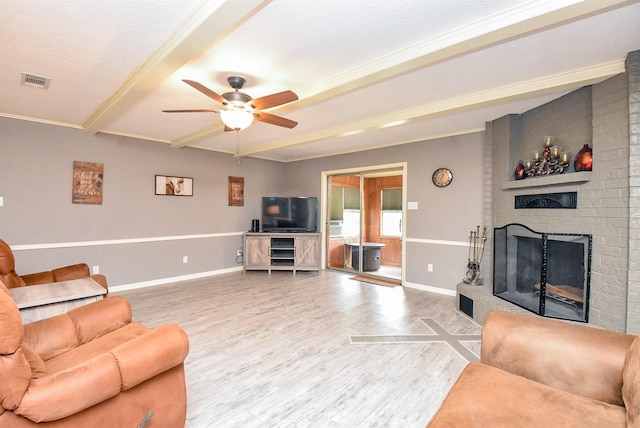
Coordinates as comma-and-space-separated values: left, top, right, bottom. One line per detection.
262, 196, 318, 232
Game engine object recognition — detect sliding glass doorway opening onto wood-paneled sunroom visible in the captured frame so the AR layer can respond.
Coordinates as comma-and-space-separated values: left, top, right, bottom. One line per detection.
323, 164, 406, 284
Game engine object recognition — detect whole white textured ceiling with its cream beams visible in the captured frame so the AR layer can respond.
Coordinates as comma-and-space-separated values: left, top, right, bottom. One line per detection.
0, 0, 640, 162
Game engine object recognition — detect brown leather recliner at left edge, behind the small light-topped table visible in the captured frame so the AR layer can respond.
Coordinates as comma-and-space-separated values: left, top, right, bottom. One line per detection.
0, 239, 109, 293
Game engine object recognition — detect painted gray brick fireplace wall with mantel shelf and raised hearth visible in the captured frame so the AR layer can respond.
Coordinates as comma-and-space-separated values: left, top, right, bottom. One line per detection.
458, 51, 640, 334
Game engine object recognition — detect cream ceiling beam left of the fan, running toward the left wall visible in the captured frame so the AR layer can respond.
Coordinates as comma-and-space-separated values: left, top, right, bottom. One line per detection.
82, 0, 272, 134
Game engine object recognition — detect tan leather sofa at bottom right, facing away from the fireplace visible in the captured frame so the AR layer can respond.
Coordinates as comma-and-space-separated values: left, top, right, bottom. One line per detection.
428, 311, 640, 428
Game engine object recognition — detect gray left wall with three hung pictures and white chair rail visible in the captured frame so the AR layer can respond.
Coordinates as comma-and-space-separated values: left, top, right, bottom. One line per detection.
0, 118, 285, 286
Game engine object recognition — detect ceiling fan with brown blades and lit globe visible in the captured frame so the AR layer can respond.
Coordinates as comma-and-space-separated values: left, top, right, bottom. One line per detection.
162, 76, 298, 131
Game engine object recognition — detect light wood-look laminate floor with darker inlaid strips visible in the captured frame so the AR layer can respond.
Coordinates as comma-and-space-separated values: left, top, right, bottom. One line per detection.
114, 271, 480, 428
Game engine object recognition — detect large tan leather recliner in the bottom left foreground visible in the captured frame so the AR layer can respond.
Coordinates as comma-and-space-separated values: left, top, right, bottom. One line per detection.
0, 282, 189, 428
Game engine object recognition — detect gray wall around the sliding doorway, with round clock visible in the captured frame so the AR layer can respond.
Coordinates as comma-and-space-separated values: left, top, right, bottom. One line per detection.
286, 133, 484, 294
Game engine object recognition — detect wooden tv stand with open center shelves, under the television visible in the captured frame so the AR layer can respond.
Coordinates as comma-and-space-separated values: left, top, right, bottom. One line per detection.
244, 232, 320, 273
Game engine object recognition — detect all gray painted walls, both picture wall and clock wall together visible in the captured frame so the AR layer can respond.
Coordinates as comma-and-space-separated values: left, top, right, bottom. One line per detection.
0, 118, 484, 292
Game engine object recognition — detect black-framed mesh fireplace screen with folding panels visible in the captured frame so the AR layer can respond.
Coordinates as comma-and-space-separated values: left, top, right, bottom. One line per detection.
493, 223, 592, 322
